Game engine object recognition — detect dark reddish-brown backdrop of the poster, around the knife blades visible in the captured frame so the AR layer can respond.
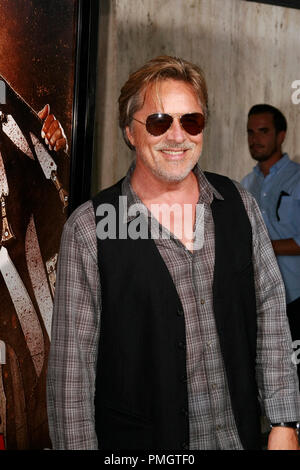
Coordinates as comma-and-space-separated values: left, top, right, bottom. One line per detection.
0, 0, 77, 449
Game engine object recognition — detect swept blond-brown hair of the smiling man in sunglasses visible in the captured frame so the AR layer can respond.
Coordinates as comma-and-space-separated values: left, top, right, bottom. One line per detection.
119, 56, 208, 150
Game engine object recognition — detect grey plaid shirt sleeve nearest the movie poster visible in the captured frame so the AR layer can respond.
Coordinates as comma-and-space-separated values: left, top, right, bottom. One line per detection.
47, 202, 101, 450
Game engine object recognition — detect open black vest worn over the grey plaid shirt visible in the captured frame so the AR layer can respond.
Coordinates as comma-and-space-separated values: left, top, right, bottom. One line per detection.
93, 173, 260, 450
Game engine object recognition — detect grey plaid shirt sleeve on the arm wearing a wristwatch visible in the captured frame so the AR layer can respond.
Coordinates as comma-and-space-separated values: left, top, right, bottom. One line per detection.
239, 187, 300, 423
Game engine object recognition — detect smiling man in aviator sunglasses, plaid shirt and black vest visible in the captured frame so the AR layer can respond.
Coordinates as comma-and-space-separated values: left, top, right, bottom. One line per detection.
48, 56, 300, 451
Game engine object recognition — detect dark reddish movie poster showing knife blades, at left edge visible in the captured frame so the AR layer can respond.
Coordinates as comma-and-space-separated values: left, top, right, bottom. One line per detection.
0, 0, 77, 449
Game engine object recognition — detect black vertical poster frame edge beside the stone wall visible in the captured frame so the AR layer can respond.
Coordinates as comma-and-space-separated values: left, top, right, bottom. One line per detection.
69, 0, 100, 214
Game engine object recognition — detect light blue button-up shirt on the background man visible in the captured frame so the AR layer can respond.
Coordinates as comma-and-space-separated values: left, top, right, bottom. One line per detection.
241, 153, 300, 303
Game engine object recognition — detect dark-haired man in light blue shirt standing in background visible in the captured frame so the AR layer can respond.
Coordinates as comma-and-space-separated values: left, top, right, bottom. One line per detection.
242, 104, 300, 388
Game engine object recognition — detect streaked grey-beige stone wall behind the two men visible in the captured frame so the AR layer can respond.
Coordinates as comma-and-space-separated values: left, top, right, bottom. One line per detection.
93, 0, 300, 193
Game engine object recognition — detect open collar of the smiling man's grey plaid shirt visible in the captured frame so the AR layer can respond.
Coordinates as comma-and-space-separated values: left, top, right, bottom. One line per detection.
122, 161, 224, 222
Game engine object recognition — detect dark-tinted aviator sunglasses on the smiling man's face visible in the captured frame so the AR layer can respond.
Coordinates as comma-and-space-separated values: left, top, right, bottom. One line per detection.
133, 113, 205, 136
